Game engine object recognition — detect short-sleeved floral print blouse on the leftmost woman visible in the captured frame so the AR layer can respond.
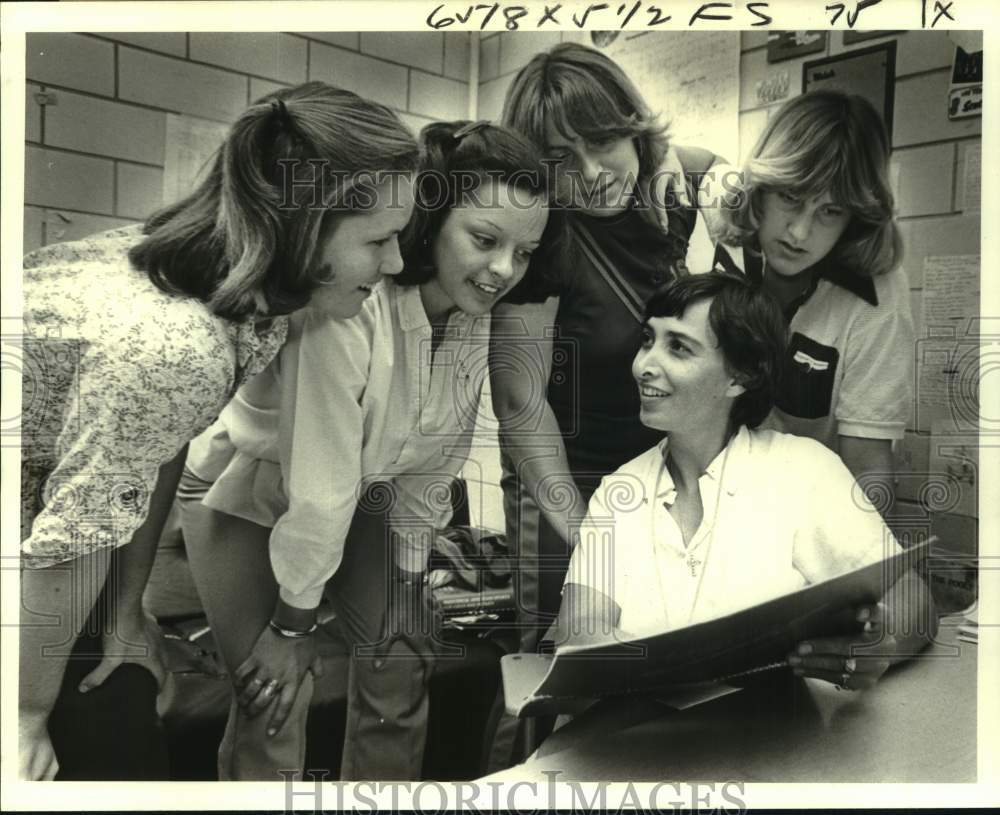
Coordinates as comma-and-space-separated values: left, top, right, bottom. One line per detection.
21, 226, 287, 568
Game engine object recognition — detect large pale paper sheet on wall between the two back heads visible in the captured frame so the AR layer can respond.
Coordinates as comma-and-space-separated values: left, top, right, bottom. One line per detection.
601, 31, 740, 167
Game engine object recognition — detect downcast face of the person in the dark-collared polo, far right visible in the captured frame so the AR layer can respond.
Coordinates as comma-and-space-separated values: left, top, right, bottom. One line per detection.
757, 190, 851, 277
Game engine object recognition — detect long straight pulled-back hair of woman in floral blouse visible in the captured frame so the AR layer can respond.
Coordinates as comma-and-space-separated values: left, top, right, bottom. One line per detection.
129, 82, 419, 320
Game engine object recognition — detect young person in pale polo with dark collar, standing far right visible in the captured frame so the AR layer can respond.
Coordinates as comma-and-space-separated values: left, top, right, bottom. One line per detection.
718, 90, 914, 513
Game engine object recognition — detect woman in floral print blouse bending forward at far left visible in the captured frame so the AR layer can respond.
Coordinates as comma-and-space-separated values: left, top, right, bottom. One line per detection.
19, 82, 418, 779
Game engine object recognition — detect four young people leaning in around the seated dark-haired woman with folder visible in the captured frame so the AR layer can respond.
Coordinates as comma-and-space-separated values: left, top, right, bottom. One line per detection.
19, 44, 924, 780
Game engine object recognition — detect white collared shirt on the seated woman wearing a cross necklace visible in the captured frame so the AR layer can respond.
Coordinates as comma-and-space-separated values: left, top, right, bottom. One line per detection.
566, 427, 899, 636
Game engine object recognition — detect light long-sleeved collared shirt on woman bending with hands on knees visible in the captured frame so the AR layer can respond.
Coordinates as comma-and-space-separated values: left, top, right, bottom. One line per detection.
188, 282, 490, 608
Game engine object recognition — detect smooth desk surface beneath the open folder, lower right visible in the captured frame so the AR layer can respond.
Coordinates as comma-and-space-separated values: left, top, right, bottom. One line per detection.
489, 618, 977, 783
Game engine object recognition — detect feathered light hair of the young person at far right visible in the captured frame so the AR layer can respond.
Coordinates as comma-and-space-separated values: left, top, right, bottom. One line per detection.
722, 90, 903, 276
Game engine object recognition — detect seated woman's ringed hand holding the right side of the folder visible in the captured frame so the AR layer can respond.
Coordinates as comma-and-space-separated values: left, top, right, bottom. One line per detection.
788, 602, 898, 690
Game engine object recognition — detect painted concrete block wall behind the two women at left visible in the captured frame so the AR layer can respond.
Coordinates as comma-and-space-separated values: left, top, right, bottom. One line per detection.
24, 32, 470, 251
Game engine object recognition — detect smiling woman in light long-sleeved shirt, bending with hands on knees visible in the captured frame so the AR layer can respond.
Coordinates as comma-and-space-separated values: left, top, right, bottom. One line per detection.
180, 122, 548, 780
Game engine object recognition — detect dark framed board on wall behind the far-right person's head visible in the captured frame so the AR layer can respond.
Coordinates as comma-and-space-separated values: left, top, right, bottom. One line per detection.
802, 41, 896, 138
